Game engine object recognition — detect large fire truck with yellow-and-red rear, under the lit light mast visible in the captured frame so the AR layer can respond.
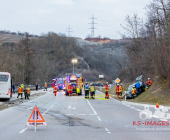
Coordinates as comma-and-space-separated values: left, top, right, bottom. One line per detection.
65, 73, 83, 96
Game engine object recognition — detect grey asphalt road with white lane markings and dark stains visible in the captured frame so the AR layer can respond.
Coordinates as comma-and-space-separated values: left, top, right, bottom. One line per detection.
0, 90, 170, 140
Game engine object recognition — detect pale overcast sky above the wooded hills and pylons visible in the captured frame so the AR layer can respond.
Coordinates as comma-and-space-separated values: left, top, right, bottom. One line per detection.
0, 0, 151, 39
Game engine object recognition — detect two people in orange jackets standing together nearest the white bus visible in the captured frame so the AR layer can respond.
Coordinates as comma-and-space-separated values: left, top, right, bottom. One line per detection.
17, 84, 31, 100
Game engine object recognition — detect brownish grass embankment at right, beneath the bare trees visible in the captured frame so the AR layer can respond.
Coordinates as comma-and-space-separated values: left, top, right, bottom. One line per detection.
97, 79, 170, 106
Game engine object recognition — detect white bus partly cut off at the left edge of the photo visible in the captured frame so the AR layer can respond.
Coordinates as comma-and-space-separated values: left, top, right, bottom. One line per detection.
0, 72, 12, 99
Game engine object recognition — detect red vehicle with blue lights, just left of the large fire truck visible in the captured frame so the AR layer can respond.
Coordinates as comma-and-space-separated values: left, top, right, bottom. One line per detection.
51, 78, 65, 90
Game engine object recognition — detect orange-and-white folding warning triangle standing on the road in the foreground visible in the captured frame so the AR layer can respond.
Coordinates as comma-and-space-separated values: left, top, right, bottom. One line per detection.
26, 106, 47, 131
